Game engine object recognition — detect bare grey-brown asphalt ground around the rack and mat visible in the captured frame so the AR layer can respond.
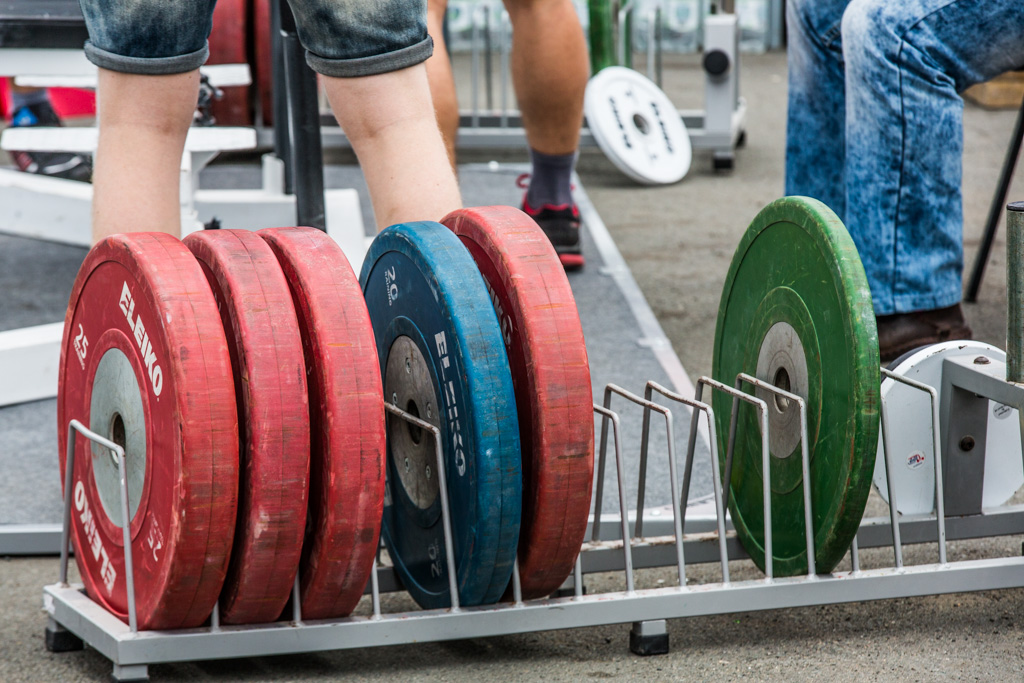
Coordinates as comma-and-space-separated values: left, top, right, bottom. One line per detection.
0, 54, 1024, 681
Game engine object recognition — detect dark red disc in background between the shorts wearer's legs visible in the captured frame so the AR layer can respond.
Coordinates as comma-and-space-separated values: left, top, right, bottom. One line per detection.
207, 0, 253, 126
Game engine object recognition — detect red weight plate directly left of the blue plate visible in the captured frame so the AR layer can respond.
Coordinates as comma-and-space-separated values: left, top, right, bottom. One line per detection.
259, 227, 384, 620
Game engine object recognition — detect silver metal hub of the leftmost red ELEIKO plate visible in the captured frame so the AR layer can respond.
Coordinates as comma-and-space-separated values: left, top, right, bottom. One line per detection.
89, 348, 146, 528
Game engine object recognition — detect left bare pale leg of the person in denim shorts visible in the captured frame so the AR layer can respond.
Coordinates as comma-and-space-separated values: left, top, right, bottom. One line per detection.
92, 69, 199, 244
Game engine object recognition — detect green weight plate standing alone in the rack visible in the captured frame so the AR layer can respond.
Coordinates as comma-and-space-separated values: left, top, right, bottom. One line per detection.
713, 197, 880, 577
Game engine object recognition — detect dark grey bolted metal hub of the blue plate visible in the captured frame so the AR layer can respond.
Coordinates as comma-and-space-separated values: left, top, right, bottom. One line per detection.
384, 335, 440, 510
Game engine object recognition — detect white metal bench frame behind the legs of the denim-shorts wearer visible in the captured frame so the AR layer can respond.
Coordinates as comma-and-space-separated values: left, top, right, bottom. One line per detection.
0, 48, 368, 407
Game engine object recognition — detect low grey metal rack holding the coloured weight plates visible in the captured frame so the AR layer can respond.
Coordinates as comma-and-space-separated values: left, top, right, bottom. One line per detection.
44, 194, 1024, 681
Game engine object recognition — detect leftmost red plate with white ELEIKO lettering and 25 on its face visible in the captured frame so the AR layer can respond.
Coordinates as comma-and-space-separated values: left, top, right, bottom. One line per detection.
57, 232, 239, 630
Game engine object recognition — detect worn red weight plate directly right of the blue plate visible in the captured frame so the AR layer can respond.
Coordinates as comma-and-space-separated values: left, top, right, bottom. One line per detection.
441, 207, 594, 599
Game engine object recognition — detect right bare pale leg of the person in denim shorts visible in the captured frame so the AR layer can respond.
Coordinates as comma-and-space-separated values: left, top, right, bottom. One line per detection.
324, 65, 462, 229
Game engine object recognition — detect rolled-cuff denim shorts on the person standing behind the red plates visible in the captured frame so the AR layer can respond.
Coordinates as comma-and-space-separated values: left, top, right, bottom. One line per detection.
80, 0, 433, 78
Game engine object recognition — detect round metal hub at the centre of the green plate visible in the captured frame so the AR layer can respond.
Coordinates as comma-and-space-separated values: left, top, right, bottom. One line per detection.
756, 322, 809, 458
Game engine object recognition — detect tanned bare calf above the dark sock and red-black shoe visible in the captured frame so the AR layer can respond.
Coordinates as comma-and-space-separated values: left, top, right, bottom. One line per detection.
505, 0, 590, 155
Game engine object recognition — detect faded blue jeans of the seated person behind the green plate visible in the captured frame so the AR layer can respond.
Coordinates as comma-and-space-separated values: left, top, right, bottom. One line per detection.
785, 0, 1024, 315
